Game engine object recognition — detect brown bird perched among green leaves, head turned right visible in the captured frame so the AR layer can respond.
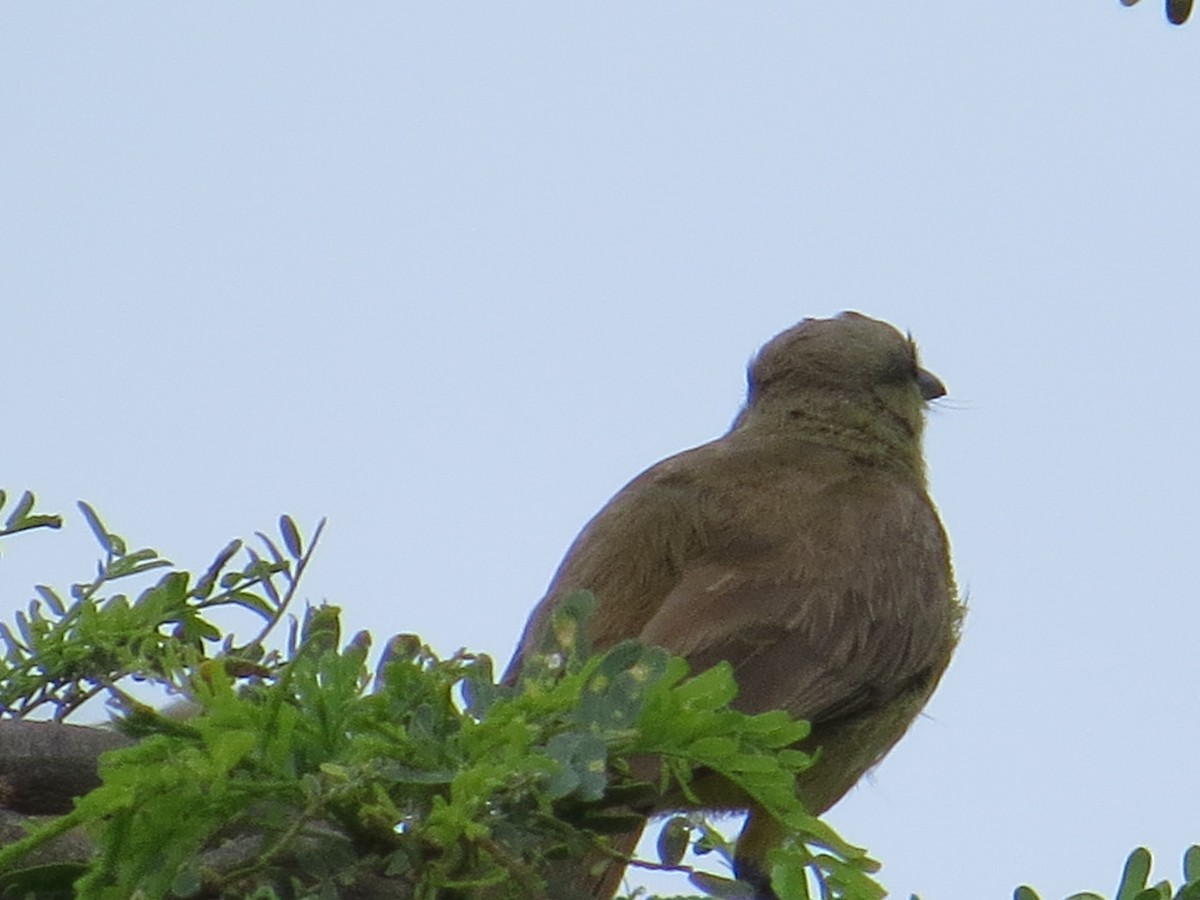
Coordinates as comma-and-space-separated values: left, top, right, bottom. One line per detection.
506, 312, 961, 900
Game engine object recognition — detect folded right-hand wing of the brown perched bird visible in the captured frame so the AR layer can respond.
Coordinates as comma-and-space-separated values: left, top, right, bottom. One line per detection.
637, 475, 954, 724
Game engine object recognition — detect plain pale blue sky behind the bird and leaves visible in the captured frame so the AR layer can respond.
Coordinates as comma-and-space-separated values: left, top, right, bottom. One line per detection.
0, 7, 1200, 900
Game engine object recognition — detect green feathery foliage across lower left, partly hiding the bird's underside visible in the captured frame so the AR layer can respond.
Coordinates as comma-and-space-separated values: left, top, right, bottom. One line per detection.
0, 496, 882, 900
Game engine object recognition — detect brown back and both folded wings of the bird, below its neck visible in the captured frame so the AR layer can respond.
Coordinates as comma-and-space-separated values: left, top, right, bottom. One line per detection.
505, 443, 954, 722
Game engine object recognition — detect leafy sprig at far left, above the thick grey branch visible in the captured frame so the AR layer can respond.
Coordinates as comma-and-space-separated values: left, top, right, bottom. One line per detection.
0, 492, 320, 721
